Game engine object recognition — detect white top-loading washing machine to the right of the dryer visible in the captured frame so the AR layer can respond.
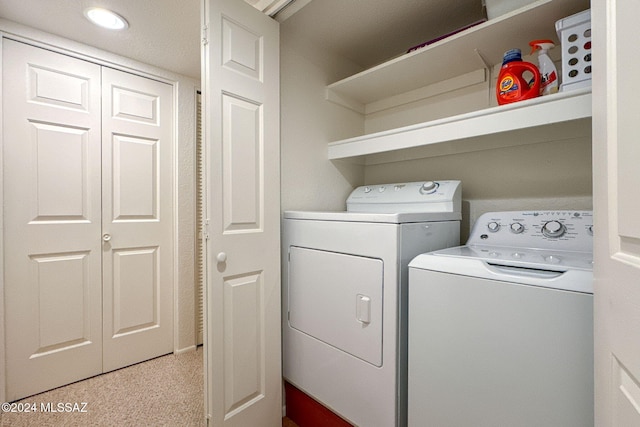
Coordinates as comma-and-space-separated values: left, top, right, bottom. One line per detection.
408, 211, 594, 427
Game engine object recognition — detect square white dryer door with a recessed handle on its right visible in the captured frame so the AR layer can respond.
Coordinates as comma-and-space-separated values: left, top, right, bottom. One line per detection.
289, 246, 383, 366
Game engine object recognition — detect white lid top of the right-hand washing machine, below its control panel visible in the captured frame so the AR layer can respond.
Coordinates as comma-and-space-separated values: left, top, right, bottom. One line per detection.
409, 246, 593, 293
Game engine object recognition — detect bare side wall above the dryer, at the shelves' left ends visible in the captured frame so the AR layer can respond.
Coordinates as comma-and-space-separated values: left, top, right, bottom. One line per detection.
280, 23, 364, 210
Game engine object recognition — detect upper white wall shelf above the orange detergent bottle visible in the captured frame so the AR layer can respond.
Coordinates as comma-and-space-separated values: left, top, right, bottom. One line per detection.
327, 0, 589, 112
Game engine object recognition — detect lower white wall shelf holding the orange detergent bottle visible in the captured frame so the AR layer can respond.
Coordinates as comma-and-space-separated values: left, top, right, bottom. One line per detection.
328, 88, 591, 165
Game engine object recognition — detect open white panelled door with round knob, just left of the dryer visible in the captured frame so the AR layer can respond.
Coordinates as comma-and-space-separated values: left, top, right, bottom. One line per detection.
203, 0, 282, 427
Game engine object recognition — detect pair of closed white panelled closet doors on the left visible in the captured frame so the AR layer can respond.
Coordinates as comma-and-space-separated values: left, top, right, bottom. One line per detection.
2, 40, 173, 400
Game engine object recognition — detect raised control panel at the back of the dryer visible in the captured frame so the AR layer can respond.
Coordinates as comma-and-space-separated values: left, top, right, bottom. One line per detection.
347, 181, 462, 213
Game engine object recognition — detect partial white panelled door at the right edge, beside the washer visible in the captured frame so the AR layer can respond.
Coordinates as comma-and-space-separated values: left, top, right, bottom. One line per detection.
591, 0, 640, 426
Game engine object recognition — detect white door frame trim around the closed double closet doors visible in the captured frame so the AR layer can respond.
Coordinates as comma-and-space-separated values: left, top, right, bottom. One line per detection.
0, 19, 200, 402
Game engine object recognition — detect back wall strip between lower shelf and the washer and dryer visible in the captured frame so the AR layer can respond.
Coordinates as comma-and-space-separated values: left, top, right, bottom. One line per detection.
365, 138, 592, 239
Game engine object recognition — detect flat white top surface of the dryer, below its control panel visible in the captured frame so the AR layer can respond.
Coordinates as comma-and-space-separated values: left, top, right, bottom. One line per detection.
284, 211, 462, 224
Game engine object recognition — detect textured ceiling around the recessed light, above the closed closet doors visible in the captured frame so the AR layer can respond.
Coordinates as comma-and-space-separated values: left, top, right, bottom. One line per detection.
0, 0, 200, 80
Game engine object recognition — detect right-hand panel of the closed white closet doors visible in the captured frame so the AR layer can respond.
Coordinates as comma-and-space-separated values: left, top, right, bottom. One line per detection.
102, 67, 174, 372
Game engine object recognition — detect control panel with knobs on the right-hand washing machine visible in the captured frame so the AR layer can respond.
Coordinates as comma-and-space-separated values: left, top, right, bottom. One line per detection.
467, 210, 593, 252
